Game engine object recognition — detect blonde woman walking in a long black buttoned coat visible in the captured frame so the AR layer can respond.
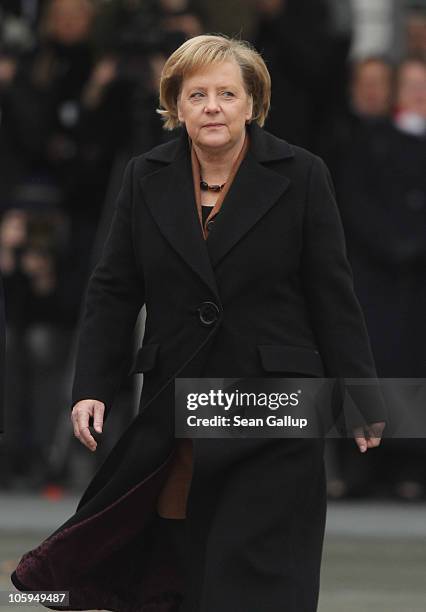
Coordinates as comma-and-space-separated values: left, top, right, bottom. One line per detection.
12, 36, 383, 612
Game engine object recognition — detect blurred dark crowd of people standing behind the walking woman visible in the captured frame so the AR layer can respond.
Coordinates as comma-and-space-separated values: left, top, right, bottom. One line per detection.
0, 0, 426, 501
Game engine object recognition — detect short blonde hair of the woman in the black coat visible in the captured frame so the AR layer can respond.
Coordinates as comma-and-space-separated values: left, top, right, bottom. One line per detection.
157, 34, 271, 130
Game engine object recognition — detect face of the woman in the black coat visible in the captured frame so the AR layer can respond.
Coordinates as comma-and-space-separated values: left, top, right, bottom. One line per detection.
178, 61, 253, 150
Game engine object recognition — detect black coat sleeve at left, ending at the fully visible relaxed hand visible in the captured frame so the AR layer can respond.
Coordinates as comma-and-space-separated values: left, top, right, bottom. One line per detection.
72, 158, 145, 420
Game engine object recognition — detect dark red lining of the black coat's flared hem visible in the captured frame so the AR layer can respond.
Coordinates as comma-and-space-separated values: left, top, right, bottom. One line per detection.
11, 451, 183, 612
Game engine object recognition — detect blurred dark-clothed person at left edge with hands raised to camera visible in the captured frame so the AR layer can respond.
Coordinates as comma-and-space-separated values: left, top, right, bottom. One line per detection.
0, 202, 73, 488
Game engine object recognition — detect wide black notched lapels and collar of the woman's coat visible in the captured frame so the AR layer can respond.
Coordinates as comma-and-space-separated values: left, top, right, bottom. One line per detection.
140, 124, 294, 302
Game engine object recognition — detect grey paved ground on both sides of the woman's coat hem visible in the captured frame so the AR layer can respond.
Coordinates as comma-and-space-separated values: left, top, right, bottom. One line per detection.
0, 494, 426, 612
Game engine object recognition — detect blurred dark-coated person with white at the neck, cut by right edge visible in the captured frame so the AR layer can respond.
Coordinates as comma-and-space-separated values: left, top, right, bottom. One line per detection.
377, 55, 426, 500
